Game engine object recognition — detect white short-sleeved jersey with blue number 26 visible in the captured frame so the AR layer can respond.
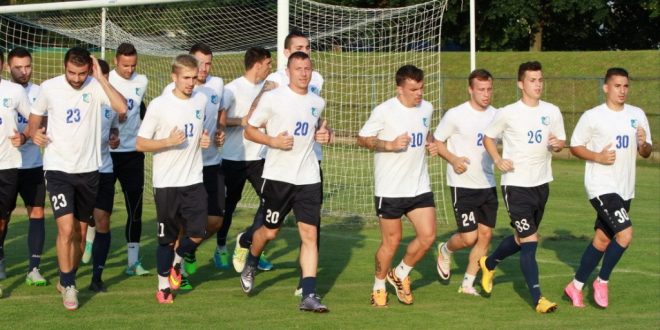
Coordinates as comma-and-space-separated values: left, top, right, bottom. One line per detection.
485, 101, 566, 187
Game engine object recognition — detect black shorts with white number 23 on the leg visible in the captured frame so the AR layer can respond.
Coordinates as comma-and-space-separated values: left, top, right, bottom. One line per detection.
45, 171, 99, 223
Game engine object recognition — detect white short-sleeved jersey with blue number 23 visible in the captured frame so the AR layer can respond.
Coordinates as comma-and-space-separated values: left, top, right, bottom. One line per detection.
32, 75, 110, 173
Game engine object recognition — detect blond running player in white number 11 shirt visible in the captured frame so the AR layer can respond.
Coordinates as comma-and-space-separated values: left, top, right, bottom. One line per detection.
136, 54, 211, 304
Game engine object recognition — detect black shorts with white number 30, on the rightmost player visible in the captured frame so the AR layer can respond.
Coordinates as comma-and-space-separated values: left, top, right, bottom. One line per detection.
589, 193, 632, 239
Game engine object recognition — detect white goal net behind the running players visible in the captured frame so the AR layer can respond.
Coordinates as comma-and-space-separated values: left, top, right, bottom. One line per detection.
0, 0, 451, 222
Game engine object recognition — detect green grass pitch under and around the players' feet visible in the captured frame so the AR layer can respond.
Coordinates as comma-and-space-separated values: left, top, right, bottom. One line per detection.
0, 160, 660, 329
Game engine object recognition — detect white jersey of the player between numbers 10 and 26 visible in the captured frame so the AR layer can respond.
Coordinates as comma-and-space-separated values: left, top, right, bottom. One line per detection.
433, 102, 496, 189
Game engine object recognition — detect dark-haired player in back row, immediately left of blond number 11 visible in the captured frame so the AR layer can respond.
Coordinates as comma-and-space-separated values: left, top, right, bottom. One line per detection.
110, 43, 149, 275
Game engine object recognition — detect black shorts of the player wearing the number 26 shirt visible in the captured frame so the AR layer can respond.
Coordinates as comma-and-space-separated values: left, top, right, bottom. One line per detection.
502, 183, 550, 238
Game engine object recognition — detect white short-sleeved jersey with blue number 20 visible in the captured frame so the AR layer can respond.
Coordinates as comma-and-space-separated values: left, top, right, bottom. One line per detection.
248, 86, 325, 185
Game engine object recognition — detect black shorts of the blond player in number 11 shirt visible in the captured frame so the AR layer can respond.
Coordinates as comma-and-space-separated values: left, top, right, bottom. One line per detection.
154, 183, 207, 245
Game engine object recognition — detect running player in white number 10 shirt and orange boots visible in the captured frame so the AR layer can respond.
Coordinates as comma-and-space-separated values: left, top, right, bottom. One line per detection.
358, 65, 437, 307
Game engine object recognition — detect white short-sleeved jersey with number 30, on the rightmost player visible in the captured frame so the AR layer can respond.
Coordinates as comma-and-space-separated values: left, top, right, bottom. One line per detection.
571, 104, 651, 200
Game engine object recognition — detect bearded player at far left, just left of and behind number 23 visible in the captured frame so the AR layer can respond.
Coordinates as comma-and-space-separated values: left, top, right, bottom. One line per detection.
5, 47, 48, 286
